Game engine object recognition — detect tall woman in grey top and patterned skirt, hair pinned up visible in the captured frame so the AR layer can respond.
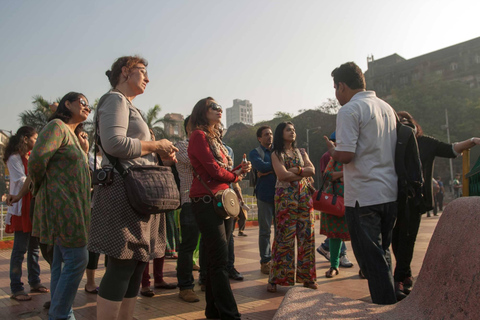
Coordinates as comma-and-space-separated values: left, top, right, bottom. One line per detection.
88, 56, 178, 320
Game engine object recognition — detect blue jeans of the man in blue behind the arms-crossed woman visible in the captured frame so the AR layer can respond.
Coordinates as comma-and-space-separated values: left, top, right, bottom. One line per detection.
257, 198, 275, 263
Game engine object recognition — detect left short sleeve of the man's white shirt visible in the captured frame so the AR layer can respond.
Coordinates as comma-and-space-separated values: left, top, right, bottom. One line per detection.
335, 106, 360, 153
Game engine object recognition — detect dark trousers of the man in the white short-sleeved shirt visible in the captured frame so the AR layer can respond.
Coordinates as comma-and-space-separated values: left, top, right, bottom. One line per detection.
345, 202, 397, 304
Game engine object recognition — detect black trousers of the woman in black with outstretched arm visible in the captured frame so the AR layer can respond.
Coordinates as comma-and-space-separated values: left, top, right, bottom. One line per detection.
392, 201, 422, 282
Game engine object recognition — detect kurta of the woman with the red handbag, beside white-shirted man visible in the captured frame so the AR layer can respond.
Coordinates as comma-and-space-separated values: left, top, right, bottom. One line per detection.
320, 159, 350, 241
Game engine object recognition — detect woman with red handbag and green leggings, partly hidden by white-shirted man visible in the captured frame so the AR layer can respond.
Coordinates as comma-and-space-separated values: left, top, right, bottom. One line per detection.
320, 159, 350, 278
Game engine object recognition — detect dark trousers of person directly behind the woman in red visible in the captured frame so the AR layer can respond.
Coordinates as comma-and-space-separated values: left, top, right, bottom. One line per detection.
177, 202, 200, 290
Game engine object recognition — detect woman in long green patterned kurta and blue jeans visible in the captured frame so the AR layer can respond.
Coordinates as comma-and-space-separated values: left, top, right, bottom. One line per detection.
28, 92, 90, 319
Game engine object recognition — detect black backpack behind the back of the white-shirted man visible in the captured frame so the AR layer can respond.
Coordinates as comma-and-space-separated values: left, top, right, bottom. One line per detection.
395, 113, 426, 214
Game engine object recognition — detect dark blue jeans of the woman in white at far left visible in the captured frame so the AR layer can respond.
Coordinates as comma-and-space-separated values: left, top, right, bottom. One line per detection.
10, 231, 40, 293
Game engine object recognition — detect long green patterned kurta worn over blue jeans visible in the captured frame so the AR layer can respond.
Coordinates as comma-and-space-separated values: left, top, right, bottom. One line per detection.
28, 119, 90, 248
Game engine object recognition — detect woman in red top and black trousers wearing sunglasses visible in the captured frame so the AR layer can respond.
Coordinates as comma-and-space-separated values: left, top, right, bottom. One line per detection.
188, 97, 251, 319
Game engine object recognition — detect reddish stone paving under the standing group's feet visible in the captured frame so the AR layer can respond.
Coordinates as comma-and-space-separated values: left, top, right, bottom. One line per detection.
0, 212, 439, 320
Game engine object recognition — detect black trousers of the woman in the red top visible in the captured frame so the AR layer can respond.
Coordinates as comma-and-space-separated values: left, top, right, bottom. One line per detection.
192, 200, 240, 320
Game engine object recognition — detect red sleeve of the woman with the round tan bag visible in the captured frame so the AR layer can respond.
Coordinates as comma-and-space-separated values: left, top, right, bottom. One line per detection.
189, 130, 238, 182
